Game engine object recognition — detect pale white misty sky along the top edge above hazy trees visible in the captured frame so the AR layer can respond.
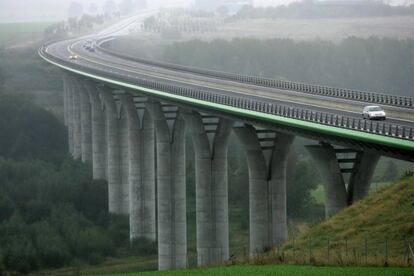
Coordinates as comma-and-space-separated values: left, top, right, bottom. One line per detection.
0, 0, 414, 22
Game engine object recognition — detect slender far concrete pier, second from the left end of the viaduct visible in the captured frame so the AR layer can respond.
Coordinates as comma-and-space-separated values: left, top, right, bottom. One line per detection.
72, 80, 82, 159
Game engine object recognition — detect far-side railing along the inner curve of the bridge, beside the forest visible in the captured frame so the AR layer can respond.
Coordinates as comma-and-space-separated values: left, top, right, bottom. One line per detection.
96, 38, 414, 109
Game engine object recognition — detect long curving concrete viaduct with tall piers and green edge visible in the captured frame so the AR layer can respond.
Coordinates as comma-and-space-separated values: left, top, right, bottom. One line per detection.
39, 17, 414, 270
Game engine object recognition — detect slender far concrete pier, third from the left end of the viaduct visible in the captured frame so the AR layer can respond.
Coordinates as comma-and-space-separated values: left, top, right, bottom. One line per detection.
79, 83, 92, 162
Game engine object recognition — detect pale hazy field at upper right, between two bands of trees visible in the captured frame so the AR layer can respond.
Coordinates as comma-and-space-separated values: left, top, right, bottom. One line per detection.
192, 16, 414, 42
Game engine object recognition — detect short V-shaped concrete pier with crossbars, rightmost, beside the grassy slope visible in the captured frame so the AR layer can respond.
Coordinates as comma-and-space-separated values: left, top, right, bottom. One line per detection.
306, 143, 380, 217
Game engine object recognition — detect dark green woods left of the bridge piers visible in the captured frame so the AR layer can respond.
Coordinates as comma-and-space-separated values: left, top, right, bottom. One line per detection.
0, 96, 156, 275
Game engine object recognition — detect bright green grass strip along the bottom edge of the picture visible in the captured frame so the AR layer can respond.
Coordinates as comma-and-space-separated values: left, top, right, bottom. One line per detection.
105, 265, 414, 276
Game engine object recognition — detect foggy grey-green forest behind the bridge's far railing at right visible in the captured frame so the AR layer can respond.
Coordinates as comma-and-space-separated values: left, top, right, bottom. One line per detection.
163, 37, 414, 96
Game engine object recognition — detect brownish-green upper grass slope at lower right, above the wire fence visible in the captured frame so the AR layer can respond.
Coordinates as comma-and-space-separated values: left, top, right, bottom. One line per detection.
297, 177, 414, 248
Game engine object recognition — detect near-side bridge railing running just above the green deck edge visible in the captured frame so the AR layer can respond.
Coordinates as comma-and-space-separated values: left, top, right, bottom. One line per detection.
40, 49, 414, 141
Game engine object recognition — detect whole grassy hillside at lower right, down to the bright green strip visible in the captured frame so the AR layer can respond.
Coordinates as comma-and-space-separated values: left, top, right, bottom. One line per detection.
284, 177, 414, 264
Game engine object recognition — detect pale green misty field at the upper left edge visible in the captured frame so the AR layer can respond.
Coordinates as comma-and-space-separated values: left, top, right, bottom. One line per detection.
0, 22, 52, 46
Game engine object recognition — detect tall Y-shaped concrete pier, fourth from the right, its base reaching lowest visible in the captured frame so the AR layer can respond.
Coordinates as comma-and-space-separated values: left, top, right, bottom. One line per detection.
147, 102, 187, 270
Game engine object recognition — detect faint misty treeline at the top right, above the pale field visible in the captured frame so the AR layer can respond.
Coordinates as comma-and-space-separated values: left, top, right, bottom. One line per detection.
232, 1, 414, 19
